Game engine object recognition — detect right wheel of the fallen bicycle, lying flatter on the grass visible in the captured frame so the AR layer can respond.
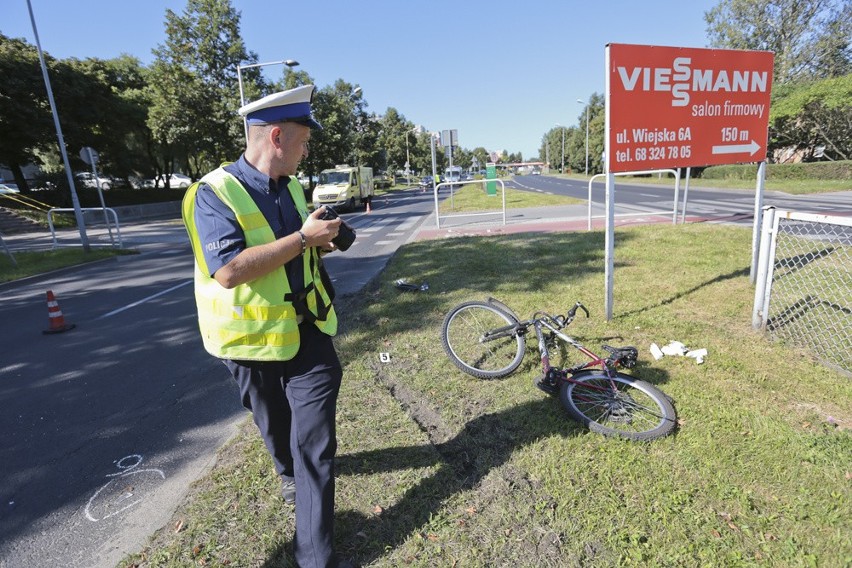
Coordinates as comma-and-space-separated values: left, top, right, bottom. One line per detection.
559, 371, 677, 441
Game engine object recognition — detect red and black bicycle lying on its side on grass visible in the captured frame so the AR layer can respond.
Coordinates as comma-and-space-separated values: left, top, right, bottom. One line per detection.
441, 298, 677, 440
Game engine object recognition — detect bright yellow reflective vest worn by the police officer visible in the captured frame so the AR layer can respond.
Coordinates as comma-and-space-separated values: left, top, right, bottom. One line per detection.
182, 168, 337, 361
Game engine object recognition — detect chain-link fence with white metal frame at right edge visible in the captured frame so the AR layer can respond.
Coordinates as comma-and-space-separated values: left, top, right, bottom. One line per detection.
753, 208, 852, 375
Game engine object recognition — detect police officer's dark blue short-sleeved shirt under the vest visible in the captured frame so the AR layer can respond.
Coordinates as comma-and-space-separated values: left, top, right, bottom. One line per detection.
195, 155, 305, 292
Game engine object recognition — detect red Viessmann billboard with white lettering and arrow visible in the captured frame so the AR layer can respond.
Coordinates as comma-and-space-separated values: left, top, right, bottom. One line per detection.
606, 43, 774, 173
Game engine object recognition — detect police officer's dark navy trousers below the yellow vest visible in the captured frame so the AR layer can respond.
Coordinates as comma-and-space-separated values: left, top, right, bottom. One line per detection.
225, 323, 343, 568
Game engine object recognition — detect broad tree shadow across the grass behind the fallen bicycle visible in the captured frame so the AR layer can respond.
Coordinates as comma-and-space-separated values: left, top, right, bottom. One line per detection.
336, 232, 633, 353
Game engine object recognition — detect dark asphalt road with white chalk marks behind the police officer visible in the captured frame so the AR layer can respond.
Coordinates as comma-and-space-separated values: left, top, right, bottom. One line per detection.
0, 187, 432, 568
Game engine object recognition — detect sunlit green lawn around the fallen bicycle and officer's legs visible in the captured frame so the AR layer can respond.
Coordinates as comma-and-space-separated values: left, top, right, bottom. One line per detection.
122, 225, 852, 568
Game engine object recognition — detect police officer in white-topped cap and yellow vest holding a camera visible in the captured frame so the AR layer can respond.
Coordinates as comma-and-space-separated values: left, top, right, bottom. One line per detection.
183, 85, 346, 568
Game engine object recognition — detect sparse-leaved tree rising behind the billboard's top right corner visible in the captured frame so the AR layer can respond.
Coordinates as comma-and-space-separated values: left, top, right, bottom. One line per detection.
704, 0, 852, 83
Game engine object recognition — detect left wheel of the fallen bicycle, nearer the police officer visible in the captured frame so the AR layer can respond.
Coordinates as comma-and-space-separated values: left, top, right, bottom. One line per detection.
441, 302, 526, 379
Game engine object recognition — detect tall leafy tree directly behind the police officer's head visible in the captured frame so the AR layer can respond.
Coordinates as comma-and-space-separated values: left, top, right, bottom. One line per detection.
148, 0, 256, 182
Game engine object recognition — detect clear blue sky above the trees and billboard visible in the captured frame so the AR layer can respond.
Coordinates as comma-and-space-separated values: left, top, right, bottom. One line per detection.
6, 0, 718, 158
